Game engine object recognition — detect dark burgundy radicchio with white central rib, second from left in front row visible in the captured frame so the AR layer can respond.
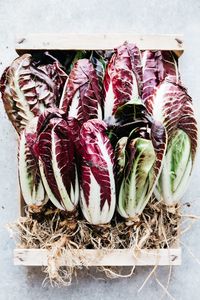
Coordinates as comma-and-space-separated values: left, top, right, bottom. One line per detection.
34, 111, 79, 212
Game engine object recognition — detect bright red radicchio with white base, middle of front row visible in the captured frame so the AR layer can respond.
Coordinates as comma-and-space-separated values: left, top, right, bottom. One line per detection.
80, 120, 116, 225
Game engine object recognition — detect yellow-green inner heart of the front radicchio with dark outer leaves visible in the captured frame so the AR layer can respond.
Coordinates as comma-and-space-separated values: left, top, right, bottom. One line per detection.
118, 138, 156, 218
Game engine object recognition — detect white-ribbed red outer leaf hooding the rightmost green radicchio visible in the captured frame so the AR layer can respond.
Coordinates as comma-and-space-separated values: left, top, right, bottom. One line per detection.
147, 76, 197, 180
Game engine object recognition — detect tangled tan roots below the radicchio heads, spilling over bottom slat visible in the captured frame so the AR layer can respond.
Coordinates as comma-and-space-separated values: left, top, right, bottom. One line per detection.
12, 199, 180, 285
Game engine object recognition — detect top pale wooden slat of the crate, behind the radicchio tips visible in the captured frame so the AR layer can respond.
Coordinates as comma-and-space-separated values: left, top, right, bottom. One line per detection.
16, 33, 184, 56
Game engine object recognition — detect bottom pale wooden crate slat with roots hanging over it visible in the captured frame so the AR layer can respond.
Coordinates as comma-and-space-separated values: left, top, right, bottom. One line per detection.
14, 248, 181, 266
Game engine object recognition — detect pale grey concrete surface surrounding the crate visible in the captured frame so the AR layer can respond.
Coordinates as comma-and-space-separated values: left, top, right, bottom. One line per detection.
0, 0, 200, 300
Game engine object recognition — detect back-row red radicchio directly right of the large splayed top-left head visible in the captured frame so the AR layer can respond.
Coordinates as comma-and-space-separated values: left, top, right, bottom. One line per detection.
60, 59, 102, 124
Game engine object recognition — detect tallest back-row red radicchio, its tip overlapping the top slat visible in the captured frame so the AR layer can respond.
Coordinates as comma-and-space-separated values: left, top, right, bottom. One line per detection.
104, 42, 142, 120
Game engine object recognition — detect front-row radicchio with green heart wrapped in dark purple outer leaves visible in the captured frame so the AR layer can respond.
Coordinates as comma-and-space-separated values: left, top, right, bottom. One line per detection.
104, 47, 167, 218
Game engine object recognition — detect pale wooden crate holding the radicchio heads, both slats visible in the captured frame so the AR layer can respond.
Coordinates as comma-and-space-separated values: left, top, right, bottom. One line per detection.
14, 34, 184, 266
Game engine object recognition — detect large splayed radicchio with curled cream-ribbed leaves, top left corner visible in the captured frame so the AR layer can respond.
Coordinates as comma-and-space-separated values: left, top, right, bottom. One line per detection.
0, 54, 67, 133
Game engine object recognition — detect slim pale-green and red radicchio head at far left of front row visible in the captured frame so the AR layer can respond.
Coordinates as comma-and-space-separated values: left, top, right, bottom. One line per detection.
18, 117, 48, 210
